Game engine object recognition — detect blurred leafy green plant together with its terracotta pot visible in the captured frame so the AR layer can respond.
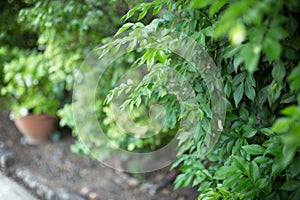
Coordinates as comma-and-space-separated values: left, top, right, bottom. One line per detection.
1, 51, 66, 144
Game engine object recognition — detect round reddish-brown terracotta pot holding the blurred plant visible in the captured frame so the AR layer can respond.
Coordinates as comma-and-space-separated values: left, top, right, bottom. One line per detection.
14, 114, 58, 144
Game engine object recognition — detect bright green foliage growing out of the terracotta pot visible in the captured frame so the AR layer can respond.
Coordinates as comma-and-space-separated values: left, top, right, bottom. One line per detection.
0, 51, 66, 117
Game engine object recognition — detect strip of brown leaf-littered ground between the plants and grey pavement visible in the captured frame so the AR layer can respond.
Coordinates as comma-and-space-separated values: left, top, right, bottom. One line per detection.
0, 111, 197, 200
